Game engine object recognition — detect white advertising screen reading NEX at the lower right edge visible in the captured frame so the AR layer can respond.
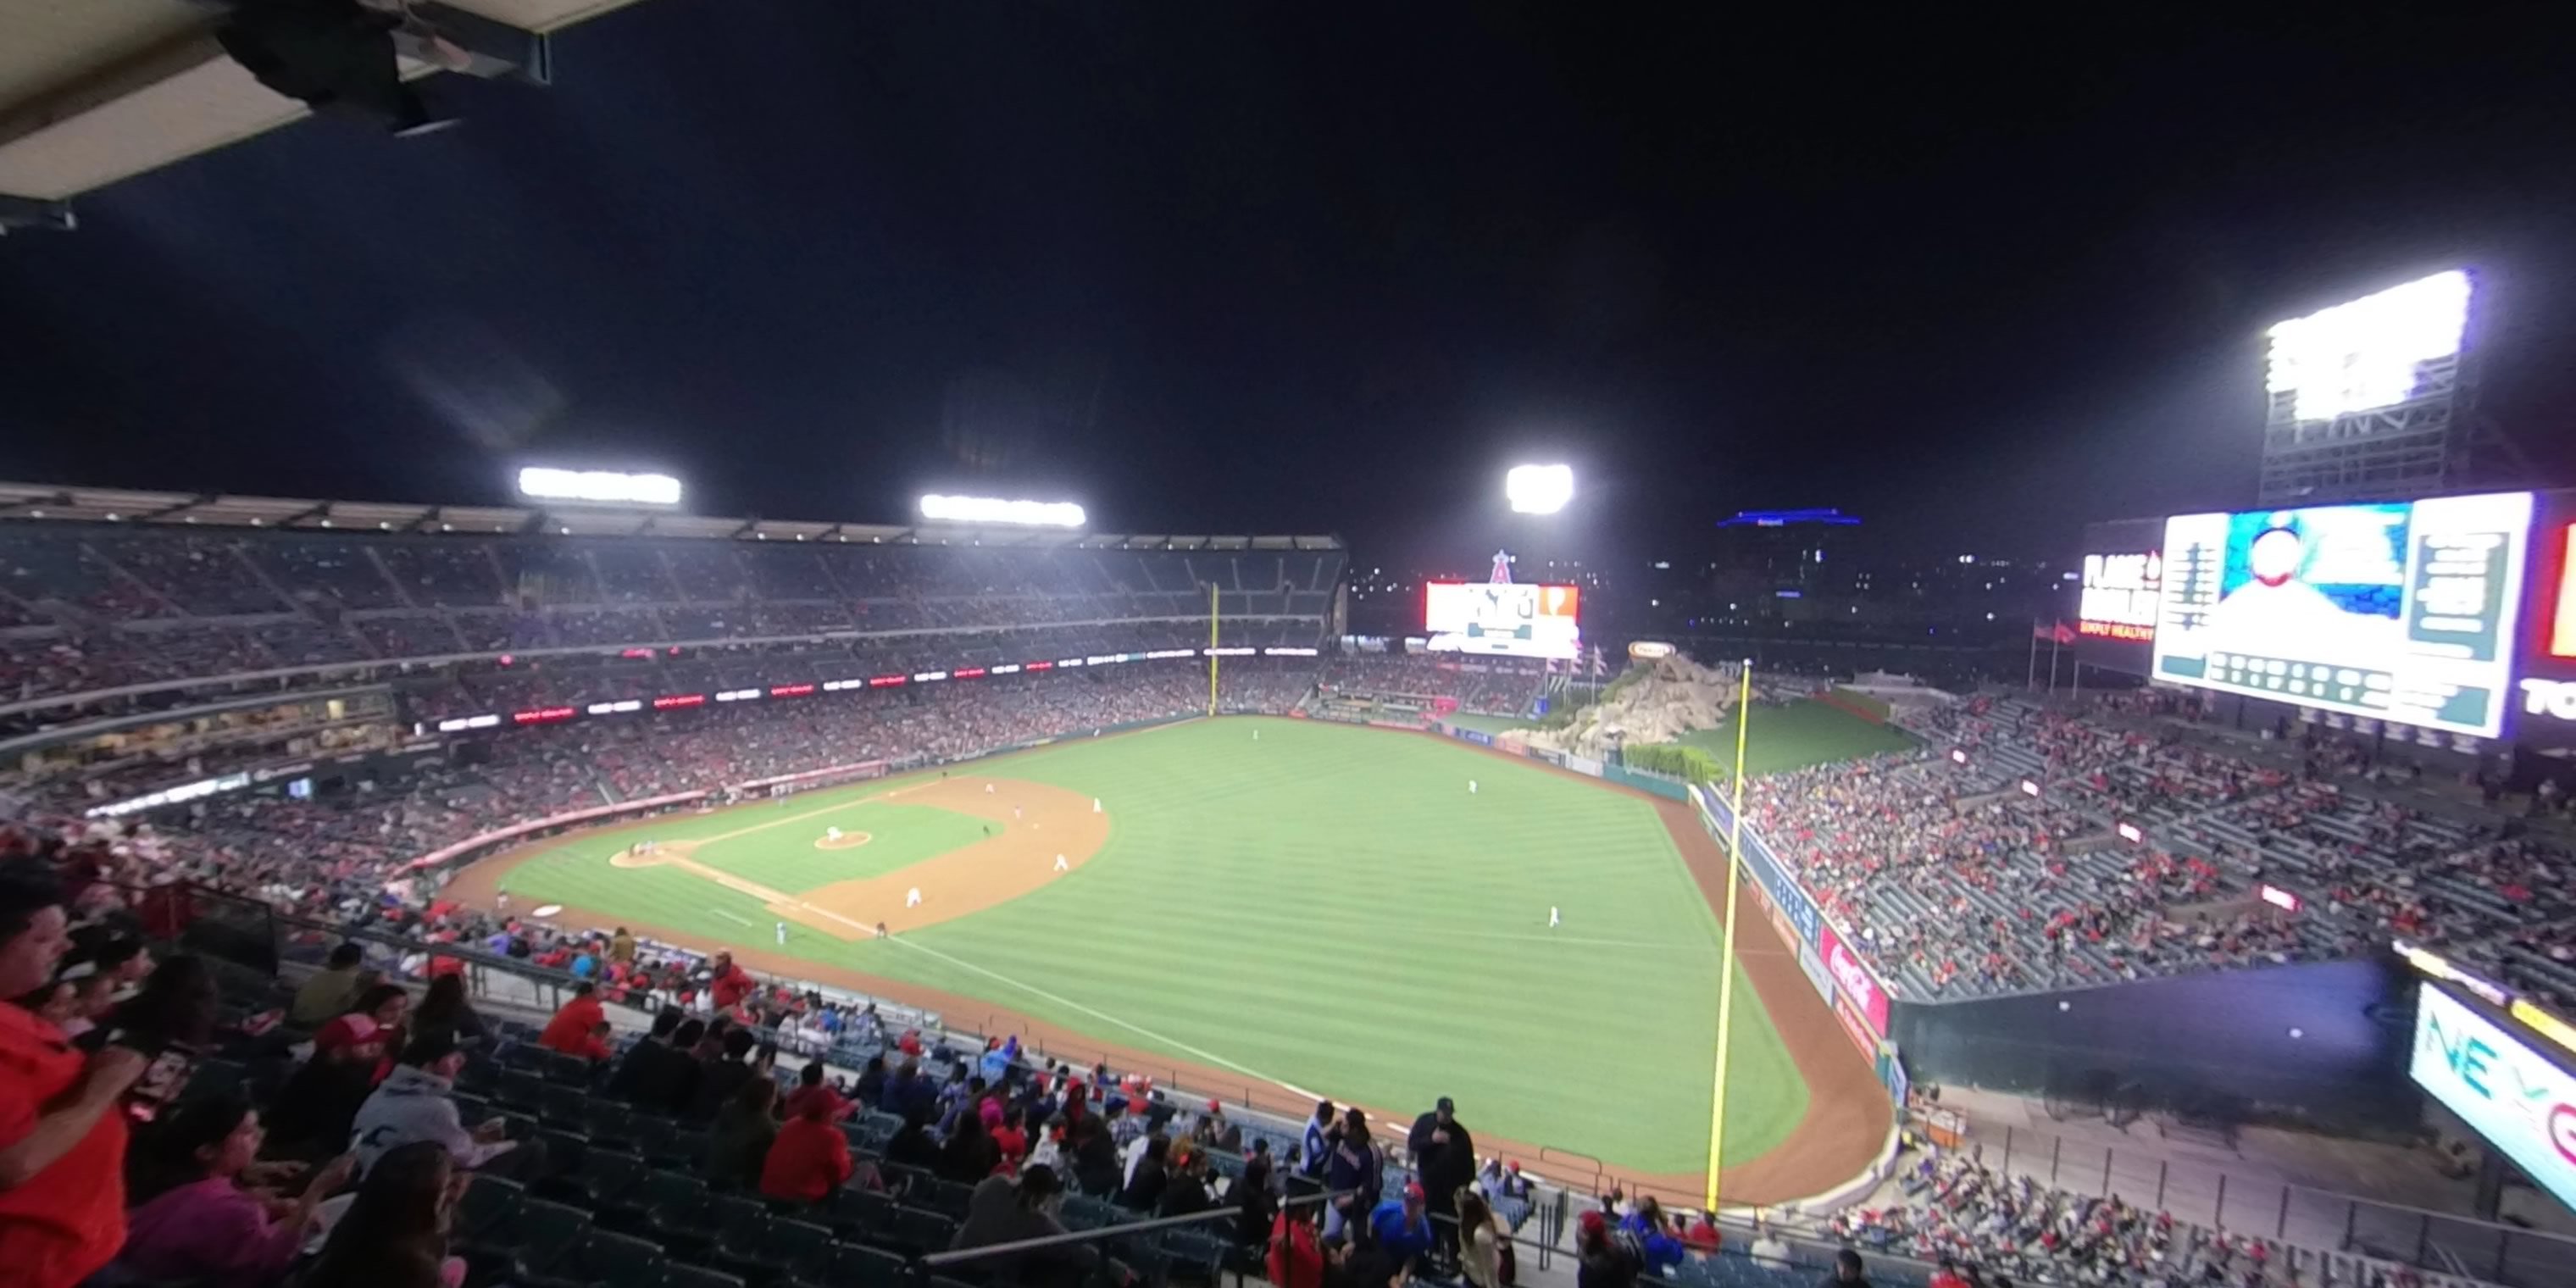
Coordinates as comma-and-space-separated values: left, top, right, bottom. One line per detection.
2408, 984, 2576, 1206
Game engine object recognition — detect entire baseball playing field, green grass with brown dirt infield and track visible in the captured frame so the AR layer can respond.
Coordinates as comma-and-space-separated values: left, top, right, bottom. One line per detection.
451, 719, 1888, 1203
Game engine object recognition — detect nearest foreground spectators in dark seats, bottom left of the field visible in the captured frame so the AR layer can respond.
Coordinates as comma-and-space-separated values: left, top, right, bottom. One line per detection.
0, 827, 1533, 1288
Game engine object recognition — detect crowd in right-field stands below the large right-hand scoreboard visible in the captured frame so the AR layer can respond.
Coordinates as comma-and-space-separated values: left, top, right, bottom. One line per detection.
1749, 696, 2576, 997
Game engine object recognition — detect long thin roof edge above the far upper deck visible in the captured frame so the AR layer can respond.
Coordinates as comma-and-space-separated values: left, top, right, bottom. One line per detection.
0, 481, 1342, 552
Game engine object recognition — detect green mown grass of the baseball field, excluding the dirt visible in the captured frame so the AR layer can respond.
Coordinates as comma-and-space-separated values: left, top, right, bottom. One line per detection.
491, 716, 1808, 1172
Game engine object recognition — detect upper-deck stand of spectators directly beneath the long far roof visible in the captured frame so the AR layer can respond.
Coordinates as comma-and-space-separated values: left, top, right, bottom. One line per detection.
0, 523, 1342, 701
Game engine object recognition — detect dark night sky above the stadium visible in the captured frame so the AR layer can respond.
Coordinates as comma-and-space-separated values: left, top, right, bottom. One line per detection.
0, 0, 2576, 567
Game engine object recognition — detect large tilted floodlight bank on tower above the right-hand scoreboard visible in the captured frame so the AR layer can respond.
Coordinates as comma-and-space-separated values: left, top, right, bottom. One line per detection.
2269, 270, 2468, 420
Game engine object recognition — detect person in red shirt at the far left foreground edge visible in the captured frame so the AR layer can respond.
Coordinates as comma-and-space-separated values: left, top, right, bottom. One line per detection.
0, 858, 144, 1288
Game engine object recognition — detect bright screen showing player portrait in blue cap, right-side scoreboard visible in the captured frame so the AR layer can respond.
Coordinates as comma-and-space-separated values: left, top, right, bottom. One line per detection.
2153, 492, 2532, 736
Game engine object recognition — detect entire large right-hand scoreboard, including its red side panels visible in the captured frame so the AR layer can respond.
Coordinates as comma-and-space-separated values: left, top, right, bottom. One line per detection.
2074, 490, 2576, 745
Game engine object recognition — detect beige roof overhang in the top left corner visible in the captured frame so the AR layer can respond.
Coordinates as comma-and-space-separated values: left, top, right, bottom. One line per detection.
0, 0, 634, 232
